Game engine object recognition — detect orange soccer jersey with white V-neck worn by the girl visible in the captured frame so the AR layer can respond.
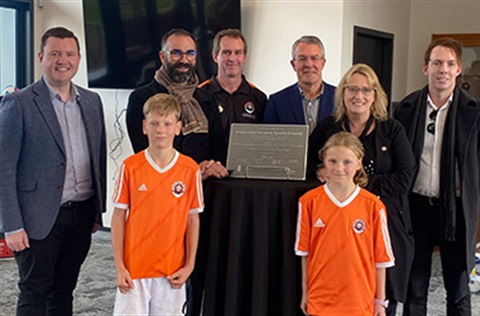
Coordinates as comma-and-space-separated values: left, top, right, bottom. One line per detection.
295, 185, 394, 315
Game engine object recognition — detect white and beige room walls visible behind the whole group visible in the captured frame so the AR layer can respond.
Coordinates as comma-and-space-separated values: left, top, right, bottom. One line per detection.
34, 0, 480, 226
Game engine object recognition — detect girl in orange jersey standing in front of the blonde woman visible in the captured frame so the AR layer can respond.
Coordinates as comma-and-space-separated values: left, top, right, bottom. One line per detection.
295, 132, 394, 316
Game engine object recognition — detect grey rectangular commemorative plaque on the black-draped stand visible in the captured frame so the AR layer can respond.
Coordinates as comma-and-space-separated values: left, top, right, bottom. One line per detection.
227, 123, 309, 180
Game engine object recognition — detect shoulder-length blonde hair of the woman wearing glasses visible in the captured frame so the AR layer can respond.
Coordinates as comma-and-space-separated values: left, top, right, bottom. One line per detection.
334, 64, 388, 122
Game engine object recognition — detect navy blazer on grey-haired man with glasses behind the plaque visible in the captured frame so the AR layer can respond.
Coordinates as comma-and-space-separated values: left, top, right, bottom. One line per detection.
263, 81, 335, 125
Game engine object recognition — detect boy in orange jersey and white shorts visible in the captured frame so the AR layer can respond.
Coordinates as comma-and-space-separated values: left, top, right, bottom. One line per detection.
111, 94, 203, 315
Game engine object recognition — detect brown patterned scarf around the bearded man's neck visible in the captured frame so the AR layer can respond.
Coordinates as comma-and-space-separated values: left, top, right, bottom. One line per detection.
155, 65, 208, 135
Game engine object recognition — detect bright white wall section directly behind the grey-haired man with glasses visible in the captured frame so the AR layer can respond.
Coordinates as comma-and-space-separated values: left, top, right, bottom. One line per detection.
242, 0, 343, 95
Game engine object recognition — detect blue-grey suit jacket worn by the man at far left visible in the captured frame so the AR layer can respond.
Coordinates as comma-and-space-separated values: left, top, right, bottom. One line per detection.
0, 78, 106, 239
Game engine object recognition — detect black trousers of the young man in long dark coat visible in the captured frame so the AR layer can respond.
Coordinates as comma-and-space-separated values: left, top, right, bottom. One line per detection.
403, 194, 471, 316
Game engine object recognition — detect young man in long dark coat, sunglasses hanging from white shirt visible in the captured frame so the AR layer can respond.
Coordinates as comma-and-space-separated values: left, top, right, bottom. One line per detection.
394, 38, 480, 315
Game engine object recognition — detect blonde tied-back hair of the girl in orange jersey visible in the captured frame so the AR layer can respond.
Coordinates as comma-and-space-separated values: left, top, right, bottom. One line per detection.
320, 132, 368, 187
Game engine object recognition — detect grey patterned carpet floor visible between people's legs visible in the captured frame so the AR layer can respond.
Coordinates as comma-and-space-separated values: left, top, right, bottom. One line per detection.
0, 231, 480, 316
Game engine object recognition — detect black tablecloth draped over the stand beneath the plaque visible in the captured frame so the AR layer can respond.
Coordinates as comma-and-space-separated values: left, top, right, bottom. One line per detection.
199, 179, 319, 316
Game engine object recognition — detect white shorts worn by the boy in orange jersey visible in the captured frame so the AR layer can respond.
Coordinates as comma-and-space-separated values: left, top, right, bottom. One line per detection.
113, 277, 187, 315
